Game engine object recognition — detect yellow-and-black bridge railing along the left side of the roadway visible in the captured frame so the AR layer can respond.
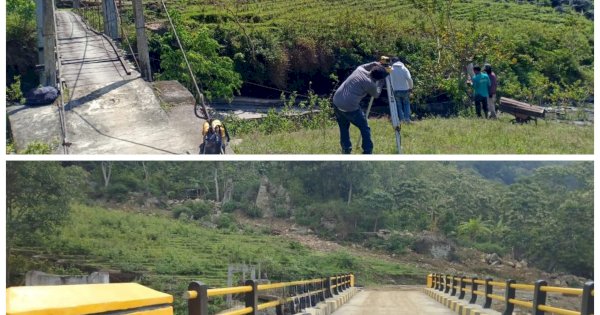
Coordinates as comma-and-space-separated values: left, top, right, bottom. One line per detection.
183, 274, 354, 315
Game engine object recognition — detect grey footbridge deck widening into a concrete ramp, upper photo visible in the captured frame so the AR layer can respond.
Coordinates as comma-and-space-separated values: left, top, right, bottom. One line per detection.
7, 10, 202, 154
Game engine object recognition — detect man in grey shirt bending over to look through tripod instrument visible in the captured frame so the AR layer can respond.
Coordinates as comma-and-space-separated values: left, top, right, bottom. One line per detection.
333, 62, 388, 154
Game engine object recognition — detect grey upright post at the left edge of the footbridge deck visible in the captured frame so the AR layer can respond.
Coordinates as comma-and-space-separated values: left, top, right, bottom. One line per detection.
41, 0, 56, 87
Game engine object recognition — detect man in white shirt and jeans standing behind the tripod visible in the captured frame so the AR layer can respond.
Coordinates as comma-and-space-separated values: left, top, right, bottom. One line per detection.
390, 58, 413, 123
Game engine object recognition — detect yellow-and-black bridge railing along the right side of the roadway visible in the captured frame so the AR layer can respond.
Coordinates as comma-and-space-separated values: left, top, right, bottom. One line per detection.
427, 273, 594, 315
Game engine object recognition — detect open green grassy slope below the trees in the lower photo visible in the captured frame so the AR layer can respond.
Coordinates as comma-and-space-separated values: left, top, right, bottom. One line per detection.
8, 205, 427, 314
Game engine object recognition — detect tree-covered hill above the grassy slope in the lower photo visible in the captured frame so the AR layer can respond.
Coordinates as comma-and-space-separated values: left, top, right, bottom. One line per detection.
7, 161, 593, 277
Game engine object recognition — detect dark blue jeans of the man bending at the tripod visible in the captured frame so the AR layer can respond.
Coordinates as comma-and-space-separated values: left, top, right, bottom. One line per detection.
333, 105, 373, 154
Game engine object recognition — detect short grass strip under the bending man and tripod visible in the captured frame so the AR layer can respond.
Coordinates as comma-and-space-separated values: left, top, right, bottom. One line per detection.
232, 115, 594, 154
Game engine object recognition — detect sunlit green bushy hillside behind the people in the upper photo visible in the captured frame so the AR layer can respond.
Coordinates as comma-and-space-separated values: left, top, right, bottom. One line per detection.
6, 0, 594, 115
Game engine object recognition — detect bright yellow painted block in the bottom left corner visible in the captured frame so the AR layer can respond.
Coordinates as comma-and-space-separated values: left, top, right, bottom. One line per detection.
6, 283, 173, 315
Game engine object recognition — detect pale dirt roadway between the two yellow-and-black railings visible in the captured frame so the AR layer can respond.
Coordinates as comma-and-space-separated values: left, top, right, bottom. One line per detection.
333, 286, 454, 315
